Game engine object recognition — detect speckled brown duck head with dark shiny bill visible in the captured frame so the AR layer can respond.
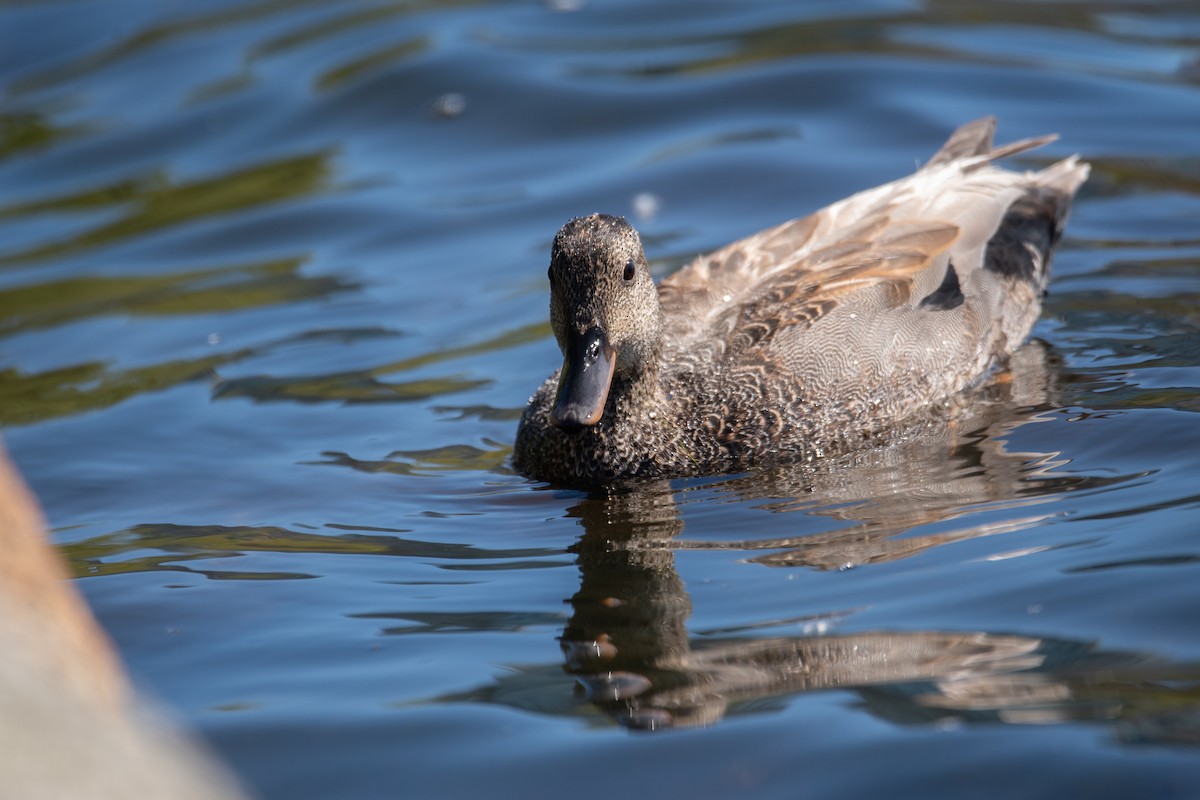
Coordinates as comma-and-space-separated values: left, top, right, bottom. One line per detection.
550, 213, 662, 433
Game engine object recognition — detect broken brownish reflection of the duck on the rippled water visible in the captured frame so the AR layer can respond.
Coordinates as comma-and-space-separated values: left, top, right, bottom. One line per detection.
549, 342, 1200, 744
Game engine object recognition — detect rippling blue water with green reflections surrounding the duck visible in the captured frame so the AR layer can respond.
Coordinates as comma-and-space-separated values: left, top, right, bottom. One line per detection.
0, 0, 1200, 799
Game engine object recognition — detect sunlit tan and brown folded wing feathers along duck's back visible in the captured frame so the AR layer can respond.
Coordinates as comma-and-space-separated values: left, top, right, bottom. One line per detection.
659, 118, 1070, 356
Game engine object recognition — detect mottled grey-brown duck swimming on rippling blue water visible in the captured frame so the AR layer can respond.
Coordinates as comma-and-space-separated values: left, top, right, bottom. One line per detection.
512, 118, 1090, 488
